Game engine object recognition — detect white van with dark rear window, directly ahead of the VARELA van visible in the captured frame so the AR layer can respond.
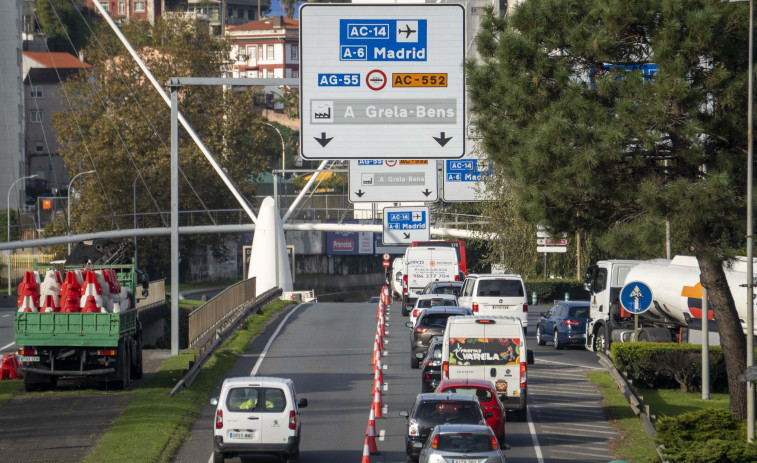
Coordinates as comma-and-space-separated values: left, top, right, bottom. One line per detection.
457, 273, 528, 336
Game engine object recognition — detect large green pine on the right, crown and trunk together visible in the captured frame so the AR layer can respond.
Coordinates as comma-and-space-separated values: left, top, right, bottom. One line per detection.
467, 0, 747, 418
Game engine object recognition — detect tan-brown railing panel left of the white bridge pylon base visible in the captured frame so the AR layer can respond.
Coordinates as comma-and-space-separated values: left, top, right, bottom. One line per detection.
187, 278, 256, 348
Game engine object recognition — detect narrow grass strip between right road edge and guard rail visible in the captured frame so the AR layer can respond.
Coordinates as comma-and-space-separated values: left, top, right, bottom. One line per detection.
587, 371, 660, 463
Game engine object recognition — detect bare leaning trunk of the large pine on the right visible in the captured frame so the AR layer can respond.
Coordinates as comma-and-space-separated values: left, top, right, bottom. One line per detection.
697, 253, 746, 420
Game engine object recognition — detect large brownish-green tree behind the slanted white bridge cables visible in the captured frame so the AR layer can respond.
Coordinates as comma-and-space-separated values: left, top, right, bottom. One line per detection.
54, 17, 281, 280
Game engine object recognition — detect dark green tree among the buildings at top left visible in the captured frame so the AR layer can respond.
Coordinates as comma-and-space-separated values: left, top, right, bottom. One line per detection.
35, 0, 90, 55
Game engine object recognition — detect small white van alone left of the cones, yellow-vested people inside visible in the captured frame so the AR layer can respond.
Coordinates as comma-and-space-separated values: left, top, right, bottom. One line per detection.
210, 376, 308, 463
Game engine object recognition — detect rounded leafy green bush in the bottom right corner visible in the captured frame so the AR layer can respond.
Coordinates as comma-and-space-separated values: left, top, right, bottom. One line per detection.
655, 409, 757, 463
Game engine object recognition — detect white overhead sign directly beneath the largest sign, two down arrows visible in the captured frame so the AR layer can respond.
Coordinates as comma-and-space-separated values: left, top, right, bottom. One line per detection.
349, 159, 439, 203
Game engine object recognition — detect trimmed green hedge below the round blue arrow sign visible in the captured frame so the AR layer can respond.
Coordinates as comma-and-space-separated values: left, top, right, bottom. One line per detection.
611, 342, 728, 392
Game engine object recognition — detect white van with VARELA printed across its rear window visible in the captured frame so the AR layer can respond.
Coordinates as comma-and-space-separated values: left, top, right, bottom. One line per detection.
442, 315, 534, 421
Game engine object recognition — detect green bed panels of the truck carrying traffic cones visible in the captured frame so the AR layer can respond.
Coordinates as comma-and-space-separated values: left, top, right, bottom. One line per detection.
13, 309, 137, 347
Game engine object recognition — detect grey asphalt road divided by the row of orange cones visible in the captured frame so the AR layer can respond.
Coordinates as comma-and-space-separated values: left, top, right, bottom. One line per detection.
175, 303, 617, 463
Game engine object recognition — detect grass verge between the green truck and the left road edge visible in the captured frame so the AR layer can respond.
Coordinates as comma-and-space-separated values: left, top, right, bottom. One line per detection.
83, 301, 292, 463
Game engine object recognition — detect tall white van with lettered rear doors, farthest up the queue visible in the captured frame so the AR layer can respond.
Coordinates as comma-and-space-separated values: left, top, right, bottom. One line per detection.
402, 246, 460, 316
